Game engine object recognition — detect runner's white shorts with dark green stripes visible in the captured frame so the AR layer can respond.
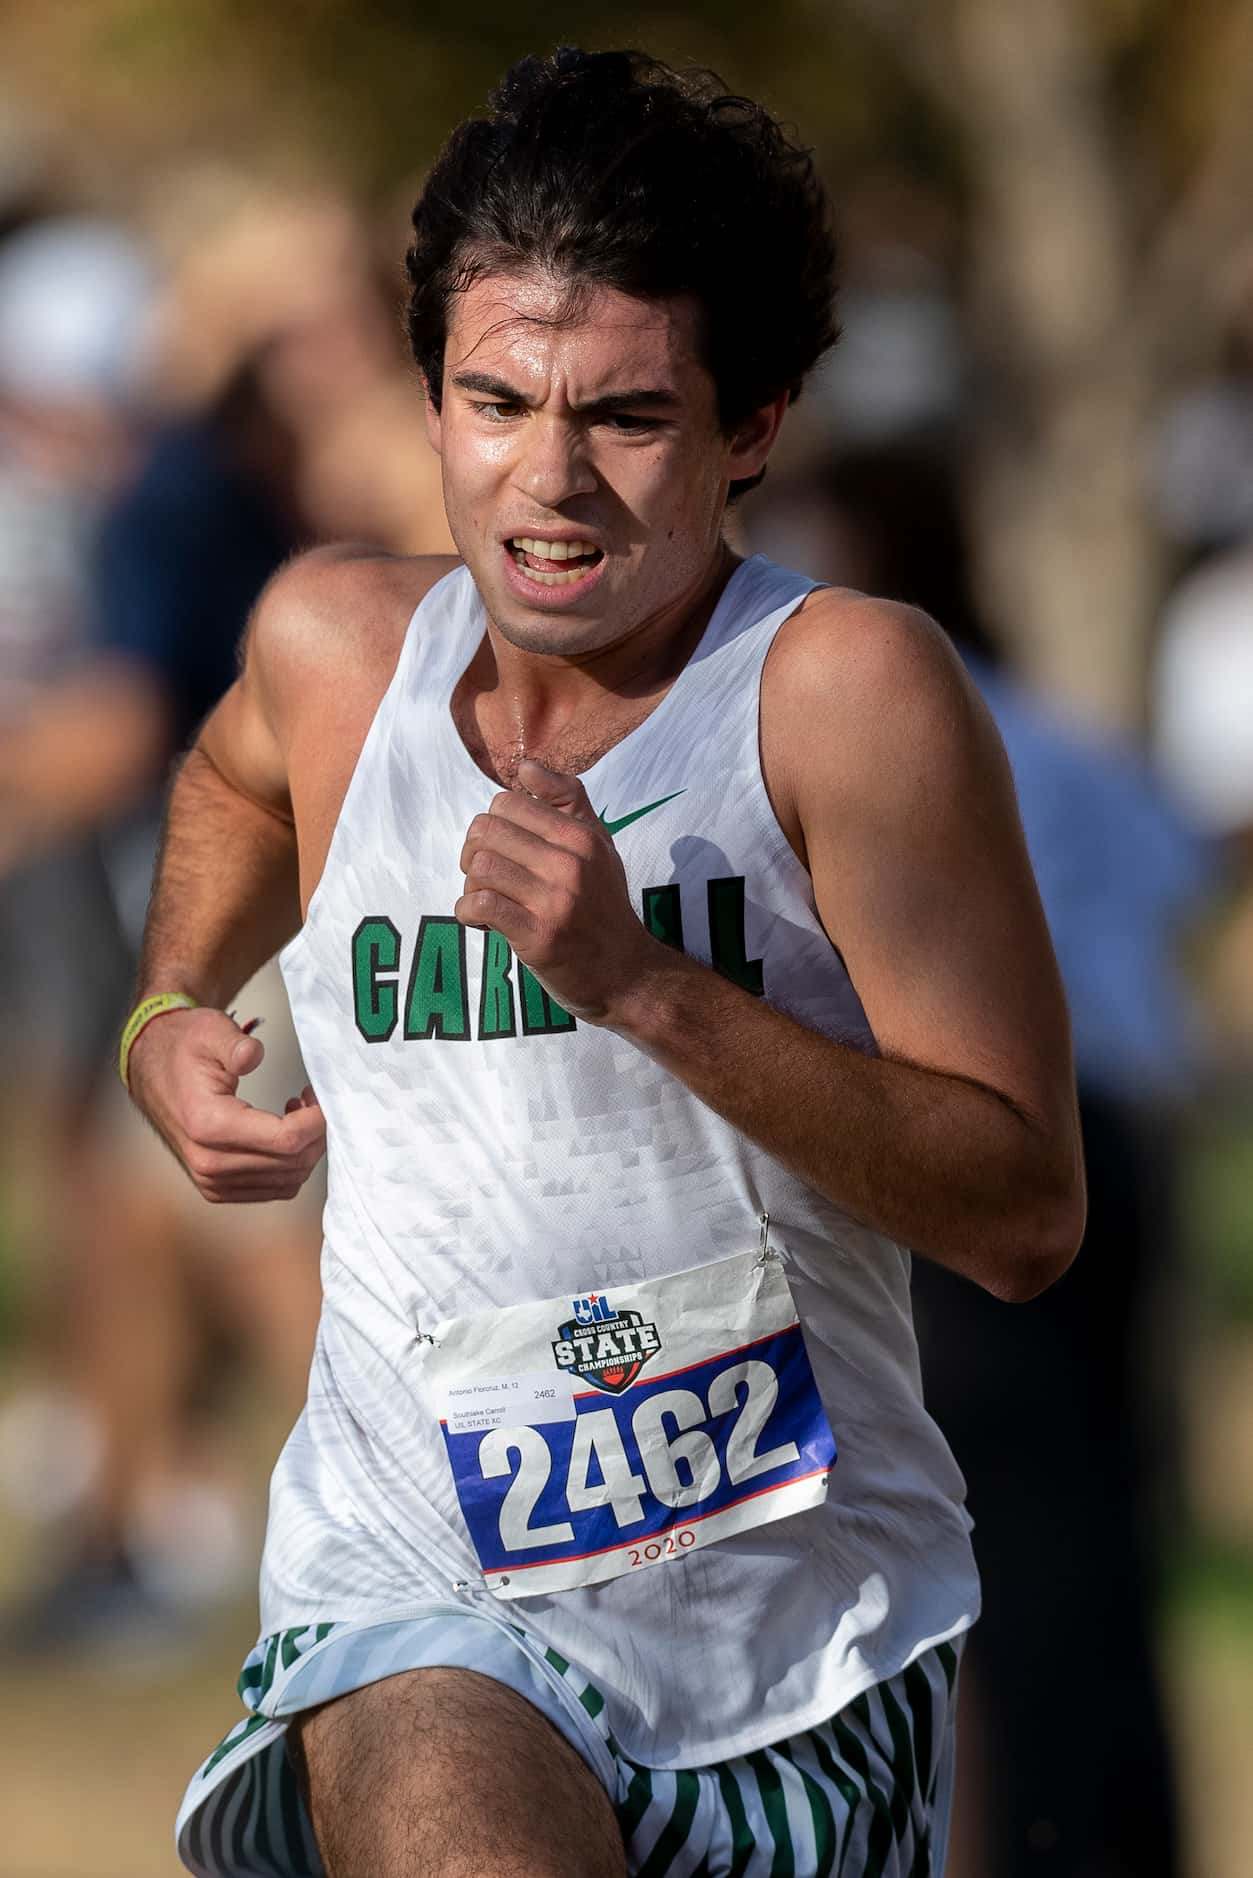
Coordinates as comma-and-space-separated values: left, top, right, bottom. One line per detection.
177, 1606, 960, 1878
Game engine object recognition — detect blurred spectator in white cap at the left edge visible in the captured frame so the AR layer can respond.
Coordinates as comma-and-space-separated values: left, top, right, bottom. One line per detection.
0, 218, 154, 1554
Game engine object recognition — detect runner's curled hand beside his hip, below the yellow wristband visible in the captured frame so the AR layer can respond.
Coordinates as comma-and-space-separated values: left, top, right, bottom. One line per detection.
130, 1010, 327, 1204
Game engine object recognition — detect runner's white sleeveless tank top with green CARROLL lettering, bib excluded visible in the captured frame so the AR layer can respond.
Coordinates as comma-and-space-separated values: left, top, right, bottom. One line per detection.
270, 556, 979, 1767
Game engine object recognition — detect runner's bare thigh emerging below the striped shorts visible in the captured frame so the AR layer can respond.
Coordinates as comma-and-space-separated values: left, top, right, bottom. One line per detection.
287, 1670, 626, 1878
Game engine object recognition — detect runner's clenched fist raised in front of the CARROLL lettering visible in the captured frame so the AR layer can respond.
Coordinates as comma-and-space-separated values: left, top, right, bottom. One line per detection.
453, 759, 665, 1024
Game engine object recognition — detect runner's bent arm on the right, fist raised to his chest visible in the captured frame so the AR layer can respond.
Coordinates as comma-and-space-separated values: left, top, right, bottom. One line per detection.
462, 599, 1082, 1298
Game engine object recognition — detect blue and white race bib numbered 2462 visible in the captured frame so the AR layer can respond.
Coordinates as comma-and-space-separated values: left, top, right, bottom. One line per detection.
425, 1251, 836, 1598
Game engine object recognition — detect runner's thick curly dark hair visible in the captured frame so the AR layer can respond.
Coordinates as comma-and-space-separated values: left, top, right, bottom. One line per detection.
406, 47, 838, 498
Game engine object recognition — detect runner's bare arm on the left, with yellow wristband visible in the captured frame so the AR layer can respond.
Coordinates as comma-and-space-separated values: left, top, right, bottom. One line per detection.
130, 548, 449, 1200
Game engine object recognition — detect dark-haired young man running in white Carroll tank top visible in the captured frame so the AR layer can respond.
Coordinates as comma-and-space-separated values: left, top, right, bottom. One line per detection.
128, 53, 1082, 1878
